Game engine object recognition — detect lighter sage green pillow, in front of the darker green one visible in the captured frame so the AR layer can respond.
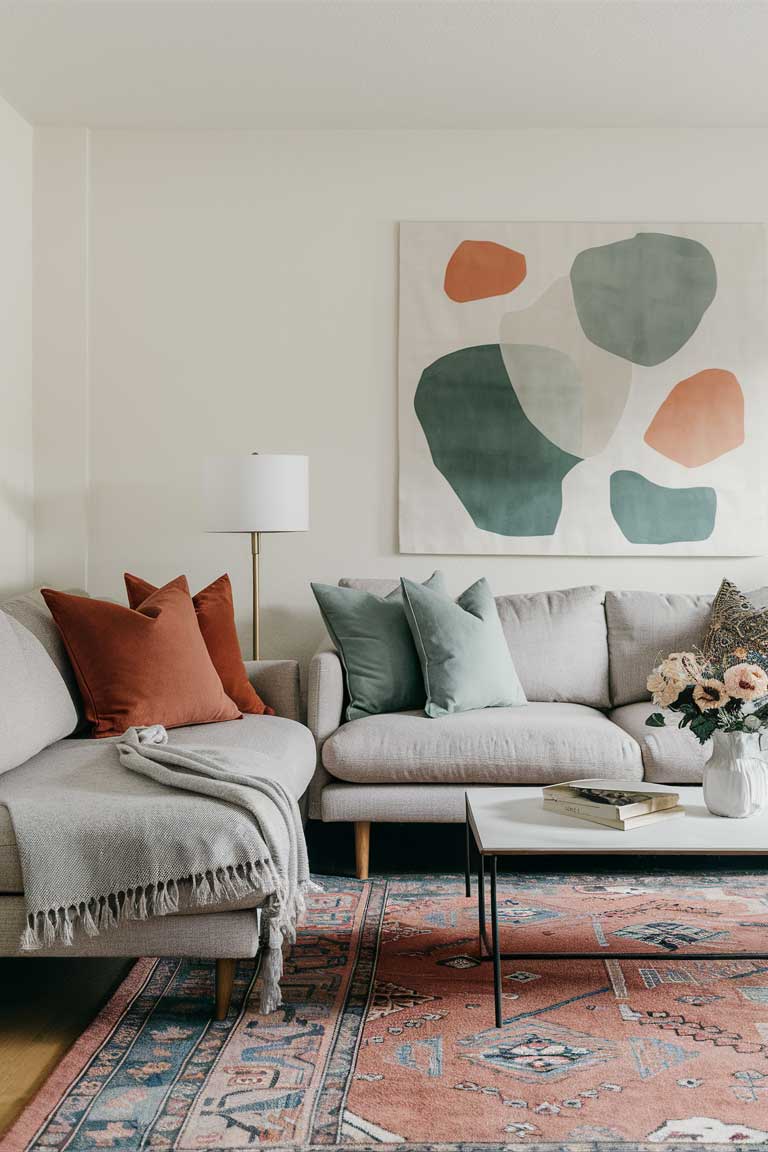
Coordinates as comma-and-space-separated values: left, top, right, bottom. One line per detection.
401, 579, 527, 718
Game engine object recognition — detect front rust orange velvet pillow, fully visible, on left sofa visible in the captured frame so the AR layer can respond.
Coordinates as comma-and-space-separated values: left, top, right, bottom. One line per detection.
41, 586, 241, 736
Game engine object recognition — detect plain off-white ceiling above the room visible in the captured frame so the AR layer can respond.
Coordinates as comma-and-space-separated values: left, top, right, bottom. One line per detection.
0, 0, 768, 129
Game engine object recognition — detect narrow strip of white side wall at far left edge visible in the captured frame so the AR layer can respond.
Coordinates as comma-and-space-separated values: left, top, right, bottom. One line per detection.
0, 100, 33, 593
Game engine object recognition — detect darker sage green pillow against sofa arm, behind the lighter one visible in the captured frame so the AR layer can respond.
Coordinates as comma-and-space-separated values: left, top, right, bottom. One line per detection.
312, 573, 446, 720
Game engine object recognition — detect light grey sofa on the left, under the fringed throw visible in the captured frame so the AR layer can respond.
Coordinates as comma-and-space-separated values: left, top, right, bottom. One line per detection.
0, 592, 315, 1018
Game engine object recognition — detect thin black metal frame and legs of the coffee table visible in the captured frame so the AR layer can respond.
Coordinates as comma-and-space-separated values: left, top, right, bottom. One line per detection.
464, 794, 768, 1028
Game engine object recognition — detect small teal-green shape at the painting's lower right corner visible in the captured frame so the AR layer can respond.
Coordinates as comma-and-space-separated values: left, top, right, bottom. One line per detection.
610, 471, 717, 544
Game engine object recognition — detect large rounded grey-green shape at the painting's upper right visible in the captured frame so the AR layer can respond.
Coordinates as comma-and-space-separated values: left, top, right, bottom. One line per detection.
571, 232, 717, 367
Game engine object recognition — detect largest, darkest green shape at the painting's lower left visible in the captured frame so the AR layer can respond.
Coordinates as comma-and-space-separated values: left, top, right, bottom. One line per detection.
413, 344, 581, 536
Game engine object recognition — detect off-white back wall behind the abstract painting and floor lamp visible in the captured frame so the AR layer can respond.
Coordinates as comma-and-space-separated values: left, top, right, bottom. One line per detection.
38, 130, 768, 654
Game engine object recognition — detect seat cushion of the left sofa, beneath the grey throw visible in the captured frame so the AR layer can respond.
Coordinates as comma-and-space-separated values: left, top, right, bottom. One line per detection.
0, 714, 315, 893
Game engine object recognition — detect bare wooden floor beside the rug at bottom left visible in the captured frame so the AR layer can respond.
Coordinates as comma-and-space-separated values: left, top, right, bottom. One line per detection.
0, 957, 131, 1132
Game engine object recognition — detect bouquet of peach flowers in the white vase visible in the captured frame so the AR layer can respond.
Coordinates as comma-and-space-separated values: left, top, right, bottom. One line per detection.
646, 649, 768, 744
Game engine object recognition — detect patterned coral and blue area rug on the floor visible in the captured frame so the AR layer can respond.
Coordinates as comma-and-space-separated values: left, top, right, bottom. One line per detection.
0, 872, 768, 1152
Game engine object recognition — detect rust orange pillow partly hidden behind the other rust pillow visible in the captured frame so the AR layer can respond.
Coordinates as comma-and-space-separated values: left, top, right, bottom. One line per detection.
124, 573, 274, 715
